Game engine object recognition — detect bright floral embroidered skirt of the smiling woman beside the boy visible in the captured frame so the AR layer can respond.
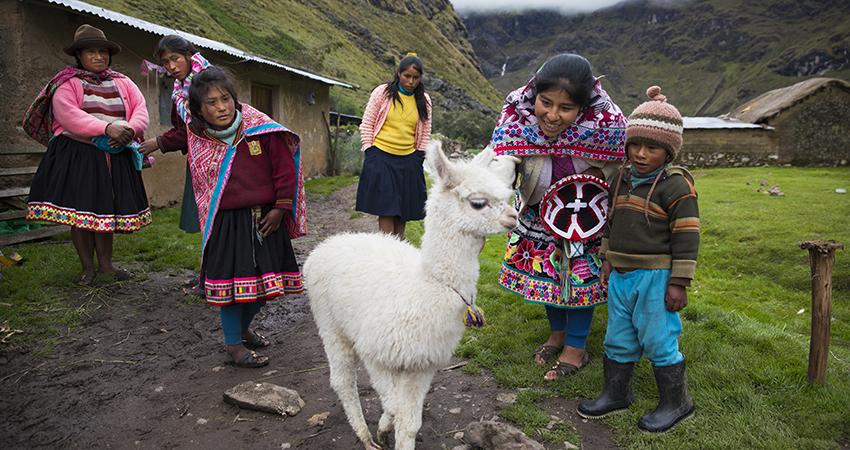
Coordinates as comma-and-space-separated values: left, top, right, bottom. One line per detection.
499, 205, 607, 308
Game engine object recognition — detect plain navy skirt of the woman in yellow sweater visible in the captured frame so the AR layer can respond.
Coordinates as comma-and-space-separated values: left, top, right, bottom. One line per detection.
355, 146, 427, 222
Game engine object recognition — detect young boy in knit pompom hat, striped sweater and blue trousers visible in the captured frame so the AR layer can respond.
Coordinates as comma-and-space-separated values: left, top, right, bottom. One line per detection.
578, 86, 699, 432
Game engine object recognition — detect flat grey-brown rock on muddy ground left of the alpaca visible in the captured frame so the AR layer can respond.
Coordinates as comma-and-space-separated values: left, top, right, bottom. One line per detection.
224, 381, 304, 416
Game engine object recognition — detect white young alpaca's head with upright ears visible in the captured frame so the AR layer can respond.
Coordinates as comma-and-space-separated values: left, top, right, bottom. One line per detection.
426, 141, 519, 236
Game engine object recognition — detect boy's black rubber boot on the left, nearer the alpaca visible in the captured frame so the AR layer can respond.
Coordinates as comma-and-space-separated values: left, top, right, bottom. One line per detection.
577, 356, 635, 419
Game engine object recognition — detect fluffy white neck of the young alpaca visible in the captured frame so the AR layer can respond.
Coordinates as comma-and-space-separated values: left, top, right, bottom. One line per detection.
421, 199, 483, 301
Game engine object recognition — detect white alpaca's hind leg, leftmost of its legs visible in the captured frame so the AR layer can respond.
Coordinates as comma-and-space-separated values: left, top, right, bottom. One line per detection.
320, 333, 380, 449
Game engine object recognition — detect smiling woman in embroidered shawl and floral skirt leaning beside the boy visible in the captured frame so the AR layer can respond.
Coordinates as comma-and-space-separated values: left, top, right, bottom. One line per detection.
491, 54, 626, 380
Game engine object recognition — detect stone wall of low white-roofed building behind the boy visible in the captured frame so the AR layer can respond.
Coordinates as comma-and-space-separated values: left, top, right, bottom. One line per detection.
678, 128, 779, 167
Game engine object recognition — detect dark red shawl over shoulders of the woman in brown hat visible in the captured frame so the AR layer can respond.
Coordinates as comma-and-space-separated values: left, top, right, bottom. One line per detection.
22, 66, 126, 145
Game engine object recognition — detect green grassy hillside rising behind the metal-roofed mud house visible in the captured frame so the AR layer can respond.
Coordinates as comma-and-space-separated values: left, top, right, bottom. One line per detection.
84, 0, 501, 113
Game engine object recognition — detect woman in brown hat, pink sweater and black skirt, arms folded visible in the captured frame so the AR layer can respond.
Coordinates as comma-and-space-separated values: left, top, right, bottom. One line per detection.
23, 25, 151, 285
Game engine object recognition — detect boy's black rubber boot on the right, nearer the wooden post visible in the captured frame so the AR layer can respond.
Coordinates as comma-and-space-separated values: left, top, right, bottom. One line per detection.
638, 361, 694, 433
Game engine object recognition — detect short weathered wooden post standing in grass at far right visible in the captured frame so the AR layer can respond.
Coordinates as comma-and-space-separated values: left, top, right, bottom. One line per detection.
800, 241, 844, 384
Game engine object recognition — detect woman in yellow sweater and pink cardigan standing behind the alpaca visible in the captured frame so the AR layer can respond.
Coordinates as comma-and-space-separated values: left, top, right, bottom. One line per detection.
355, 53, 431, 238
